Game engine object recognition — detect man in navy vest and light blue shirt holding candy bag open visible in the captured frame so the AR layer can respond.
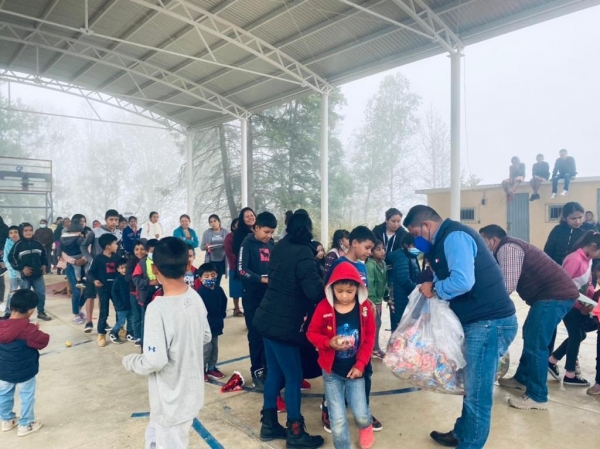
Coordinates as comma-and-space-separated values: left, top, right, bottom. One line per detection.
404, 205, 518, 449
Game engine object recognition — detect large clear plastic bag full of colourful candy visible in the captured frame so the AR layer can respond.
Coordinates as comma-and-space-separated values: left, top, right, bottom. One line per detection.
383, 287, 466, 394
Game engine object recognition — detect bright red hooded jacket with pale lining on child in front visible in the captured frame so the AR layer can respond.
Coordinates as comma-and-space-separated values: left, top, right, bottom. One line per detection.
306, 262, 375, 374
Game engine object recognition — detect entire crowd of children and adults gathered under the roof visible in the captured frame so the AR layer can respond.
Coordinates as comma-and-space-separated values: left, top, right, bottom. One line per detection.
0, 198, 600, 449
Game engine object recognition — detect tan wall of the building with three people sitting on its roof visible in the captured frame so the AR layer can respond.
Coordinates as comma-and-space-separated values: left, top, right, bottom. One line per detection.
419, 178, 600, 248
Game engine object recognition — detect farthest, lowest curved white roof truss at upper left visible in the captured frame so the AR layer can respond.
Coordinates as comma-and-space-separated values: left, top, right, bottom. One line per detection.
0, 70, 185, 133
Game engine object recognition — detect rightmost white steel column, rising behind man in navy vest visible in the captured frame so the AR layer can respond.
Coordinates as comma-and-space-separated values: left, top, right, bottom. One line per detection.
450, 51, 462, 221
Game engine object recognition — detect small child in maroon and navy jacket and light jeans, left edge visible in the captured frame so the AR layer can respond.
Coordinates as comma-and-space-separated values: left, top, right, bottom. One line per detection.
0, 290, 50, 436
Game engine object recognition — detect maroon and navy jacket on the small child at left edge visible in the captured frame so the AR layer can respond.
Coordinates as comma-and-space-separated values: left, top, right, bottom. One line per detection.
0, 318, 50, 384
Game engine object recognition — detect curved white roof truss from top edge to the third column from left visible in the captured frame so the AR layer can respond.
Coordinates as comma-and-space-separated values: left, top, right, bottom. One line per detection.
129, 0, 332, 93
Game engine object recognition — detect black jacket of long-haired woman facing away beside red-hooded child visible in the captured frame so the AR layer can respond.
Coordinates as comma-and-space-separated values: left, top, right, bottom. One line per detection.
253, 237, 325, 346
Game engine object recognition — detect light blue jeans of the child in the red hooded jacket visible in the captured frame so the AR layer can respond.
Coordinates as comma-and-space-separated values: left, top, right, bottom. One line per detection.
323, 370, 372, 449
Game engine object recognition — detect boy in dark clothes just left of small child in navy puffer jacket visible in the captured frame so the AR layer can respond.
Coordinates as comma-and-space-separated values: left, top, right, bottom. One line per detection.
86, 234, 119, 348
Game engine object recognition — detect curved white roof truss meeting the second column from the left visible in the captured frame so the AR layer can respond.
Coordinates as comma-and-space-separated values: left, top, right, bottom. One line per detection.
0, 22, 251, 119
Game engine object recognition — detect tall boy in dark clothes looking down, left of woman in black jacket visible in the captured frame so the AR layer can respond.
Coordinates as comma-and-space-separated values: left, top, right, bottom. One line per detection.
238, 212, 277, 391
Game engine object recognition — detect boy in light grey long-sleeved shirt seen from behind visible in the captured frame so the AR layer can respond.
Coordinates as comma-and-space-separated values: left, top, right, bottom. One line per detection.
123, 237, 211, 449
